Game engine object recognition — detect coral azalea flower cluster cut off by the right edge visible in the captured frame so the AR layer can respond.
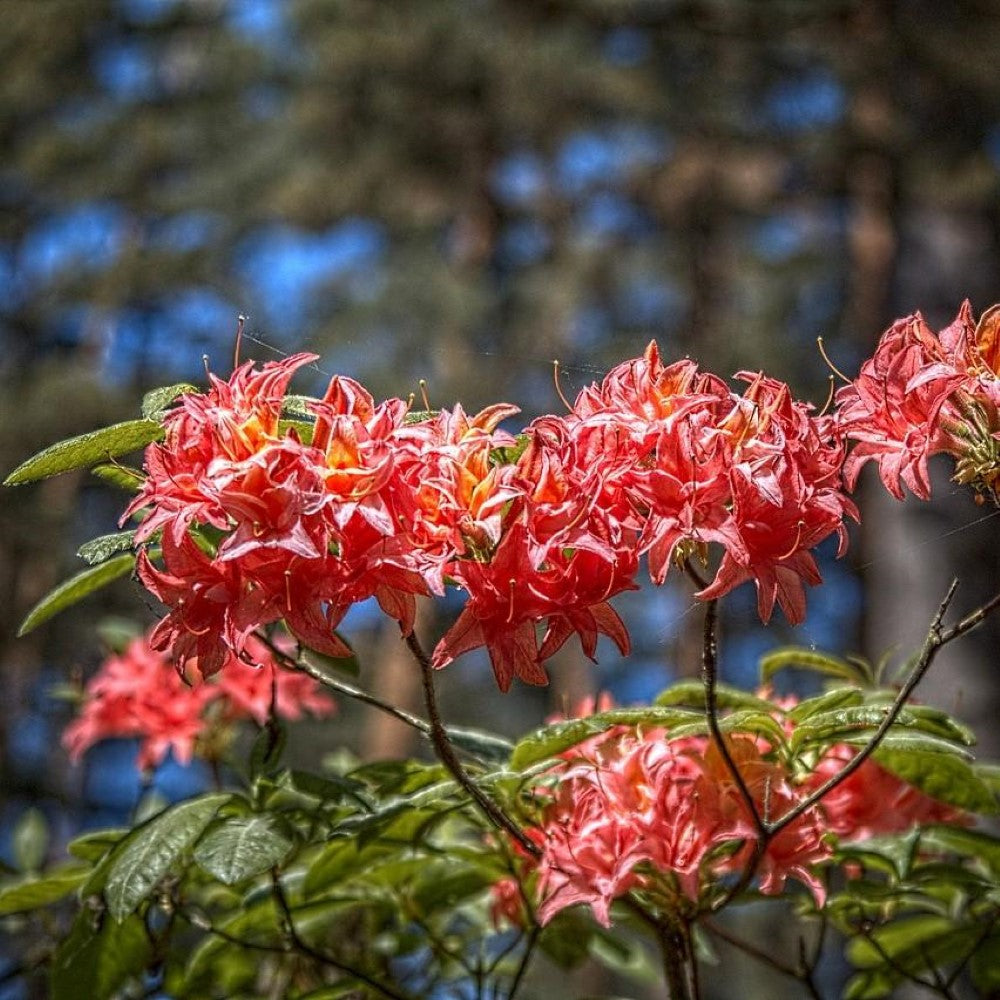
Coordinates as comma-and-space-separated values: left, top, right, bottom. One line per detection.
837, 302, 1000, 502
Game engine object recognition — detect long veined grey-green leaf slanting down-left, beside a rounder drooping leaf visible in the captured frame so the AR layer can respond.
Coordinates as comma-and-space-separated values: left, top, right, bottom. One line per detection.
104, 793, 232, 921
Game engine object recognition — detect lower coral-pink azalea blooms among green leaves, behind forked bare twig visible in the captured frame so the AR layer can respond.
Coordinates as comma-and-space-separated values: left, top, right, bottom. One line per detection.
493, 708, 966, 927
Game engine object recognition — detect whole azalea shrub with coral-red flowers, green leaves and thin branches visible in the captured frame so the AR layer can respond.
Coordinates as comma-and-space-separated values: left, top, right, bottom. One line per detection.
0, 304, 1000, 1000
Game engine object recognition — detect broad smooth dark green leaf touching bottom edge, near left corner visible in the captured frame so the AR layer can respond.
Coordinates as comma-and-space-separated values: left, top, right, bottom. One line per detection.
50, 910, 152, 1000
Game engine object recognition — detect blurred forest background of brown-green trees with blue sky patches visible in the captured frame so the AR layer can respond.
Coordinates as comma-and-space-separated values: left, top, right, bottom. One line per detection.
0, 0, 1000, 997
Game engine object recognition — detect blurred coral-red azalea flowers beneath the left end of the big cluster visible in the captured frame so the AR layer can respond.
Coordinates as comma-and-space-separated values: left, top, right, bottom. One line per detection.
63, 636, 335, 771
